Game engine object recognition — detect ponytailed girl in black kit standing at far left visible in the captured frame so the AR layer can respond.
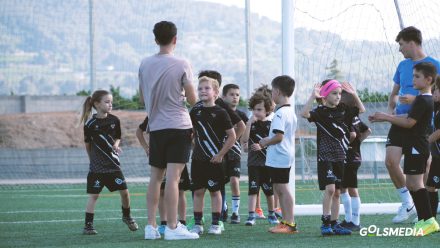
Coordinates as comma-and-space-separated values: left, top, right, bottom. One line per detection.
81, 90, 138, 235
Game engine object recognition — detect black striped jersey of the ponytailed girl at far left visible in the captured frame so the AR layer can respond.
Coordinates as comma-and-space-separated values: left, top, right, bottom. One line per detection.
84, 114, 121, 173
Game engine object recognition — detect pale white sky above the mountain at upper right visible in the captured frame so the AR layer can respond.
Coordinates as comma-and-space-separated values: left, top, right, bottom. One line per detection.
200, 0, 440, 41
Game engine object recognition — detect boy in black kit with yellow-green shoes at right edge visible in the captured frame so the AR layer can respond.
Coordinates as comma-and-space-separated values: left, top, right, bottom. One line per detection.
368, 62, 440, 236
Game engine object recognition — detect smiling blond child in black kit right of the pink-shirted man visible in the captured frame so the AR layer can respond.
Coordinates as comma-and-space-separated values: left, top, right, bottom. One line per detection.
190, 77, 236, 234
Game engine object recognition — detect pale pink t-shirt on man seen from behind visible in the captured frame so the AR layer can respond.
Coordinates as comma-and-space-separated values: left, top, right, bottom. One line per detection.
139, 54, 193, 132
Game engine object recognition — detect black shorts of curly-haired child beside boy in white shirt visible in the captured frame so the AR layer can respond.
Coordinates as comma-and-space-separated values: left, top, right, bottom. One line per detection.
248, 166, 273, 196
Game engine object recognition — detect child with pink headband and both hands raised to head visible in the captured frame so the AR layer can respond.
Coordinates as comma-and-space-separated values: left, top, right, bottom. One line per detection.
301, 79, 365, 235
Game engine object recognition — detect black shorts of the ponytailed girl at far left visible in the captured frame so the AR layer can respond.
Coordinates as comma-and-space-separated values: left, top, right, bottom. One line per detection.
87, 171, 127, 194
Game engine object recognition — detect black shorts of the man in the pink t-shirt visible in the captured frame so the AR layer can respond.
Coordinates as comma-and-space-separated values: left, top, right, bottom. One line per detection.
150, 129, 192, 169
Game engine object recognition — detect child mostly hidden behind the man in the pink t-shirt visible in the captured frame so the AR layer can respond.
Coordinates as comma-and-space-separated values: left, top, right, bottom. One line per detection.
136, 116, 191, 235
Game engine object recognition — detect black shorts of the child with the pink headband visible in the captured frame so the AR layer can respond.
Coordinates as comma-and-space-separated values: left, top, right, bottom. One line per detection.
318, 161, 344, 190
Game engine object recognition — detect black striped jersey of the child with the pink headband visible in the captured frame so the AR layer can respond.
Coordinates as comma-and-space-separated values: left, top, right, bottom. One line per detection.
308, 103, 359, 162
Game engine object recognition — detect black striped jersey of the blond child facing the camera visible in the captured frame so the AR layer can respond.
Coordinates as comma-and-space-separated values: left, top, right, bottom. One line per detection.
190, 105, 232, 161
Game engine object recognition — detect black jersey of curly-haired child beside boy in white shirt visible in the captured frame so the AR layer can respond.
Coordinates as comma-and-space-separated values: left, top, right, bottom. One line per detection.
248, 121, 271, 166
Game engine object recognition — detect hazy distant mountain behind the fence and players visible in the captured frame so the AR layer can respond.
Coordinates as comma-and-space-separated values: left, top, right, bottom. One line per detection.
0, 0, 438, 101
